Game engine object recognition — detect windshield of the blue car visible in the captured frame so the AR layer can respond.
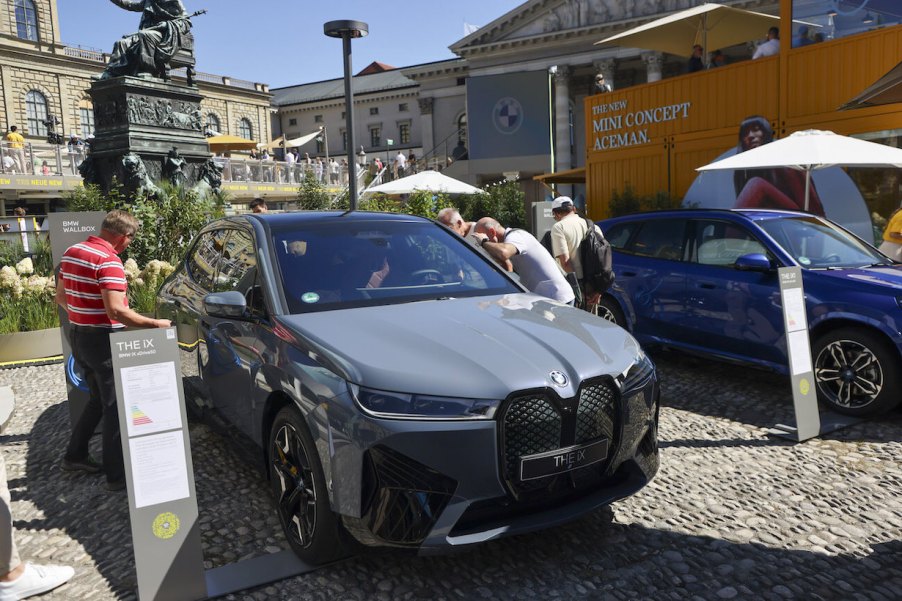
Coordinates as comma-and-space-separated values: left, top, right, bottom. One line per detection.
758, 217, 891, 269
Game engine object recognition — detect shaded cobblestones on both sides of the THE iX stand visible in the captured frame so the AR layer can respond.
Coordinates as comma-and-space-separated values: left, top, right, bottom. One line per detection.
16, 402, 288, 599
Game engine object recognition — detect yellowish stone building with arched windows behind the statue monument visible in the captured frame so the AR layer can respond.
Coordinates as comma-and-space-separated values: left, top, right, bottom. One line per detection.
0, 0, 271, 214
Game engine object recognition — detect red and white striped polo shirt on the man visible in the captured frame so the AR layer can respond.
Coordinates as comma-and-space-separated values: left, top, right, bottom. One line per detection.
59, 236, 128, 329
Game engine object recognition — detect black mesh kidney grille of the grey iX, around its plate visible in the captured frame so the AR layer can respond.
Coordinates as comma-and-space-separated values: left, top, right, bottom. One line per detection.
499, 381, 619, 498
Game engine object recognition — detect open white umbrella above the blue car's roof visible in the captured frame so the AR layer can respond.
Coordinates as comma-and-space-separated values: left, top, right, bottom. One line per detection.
696, 129, 902, 211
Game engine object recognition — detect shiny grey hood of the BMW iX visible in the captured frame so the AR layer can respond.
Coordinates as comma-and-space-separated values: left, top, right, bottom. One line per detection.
280, 294, 641, 399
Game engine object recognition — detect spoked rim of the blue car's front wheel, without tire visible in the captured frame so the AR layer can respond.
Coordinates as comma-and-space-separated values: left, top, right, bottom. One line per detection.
814, 340, 883, 409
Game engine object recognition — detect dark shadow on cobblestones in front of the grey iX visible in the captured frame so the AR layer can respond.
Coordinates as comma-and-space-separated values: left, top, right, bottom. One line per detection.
279, 505, 902, 601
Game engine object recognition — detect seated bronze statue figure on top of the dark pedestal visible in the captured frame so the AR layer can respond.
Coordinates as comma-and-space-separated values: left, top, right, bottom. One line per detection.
100, 0, 194, 79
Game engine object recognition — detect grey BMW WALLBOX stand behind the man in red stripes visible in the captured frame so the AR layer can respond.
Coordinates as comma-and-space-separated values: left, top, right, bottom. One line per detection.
47, 211, 106, 424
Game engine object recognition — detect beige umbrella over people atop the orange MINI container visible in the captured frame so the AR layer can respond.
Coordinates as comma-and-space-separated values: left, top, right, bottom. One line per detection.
595, 3, 780, 57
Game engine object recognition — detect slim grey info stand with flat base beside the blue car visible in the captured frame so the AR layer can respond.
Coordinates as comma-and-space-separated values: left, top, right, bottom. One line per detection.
768, 267, 861, 442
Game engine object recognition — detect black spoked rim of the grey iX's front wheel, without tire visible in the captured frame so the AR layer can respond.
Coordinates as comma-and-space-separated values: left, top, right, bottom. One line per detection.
271, 424, 316, 548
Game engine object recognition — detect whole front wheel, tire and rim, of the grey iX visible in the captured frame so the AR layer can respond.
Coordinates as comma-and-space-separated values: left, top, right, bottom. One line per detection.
269, 406, 344, 565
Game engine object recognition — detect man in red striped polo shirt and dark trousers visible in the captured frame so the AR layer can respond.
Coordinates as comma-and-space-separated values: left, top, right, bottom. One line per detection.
56, 210, 171, 490
